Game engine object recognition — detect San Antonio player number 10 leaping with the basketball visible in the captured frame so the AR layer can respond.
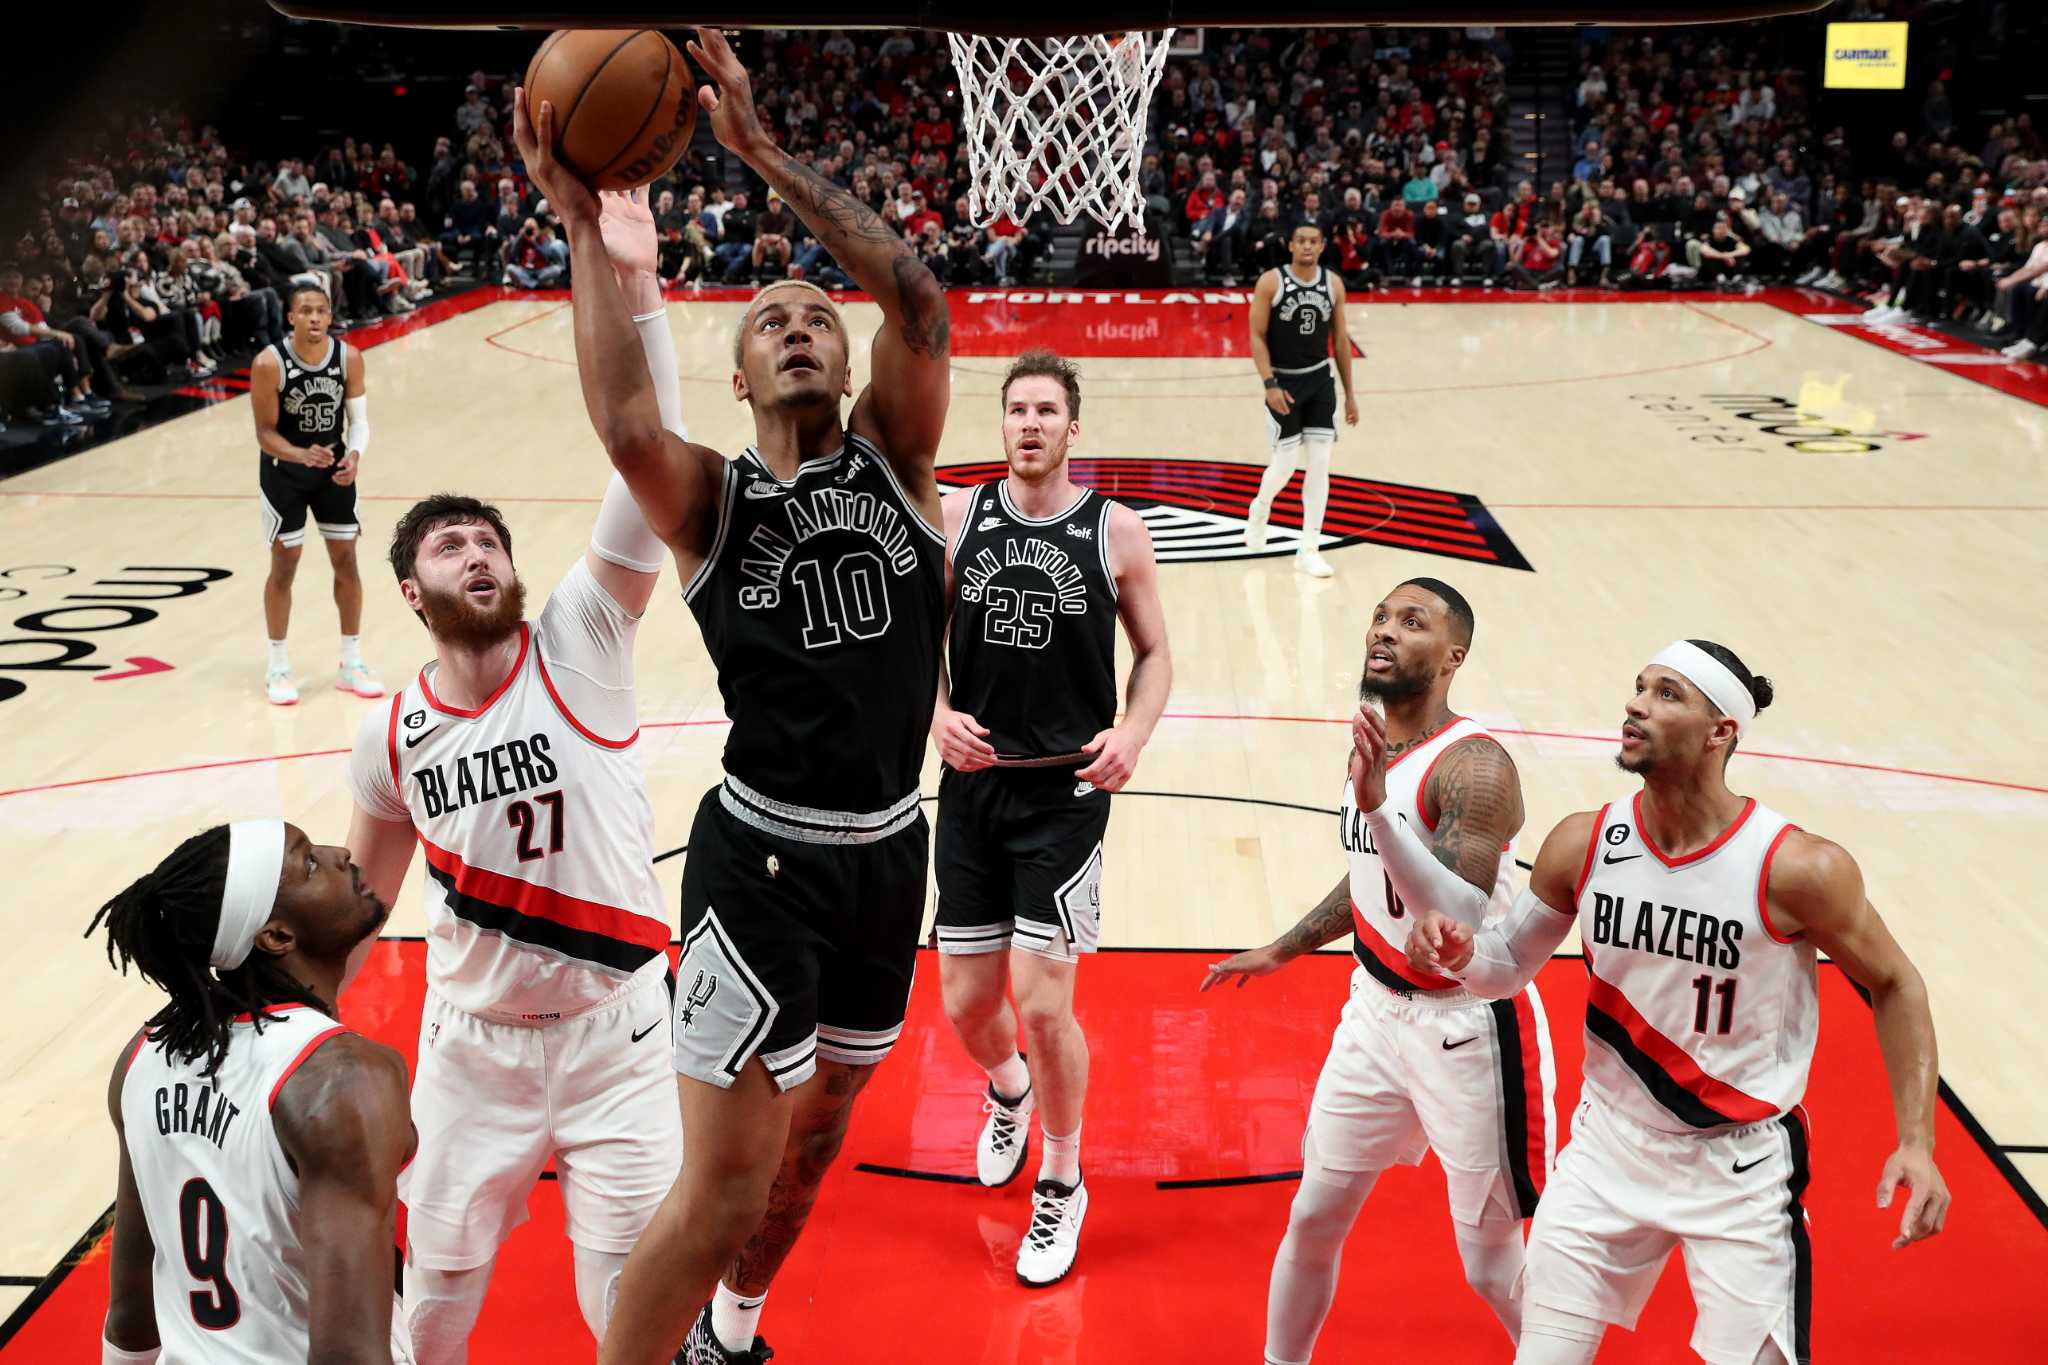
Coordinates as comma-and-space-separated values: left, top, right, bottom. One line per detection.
514, 29, 950, 1365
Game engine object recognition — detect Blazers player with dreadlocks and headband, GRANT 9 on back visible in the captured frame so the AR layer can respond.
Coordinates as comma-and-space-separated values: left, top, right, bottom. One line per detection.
88, 821, 414, 1365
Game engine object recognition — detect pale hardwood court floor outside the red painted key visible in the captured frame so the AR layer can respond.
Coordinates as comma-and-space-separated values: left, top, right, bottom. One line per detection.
0, 291, 2048, 1359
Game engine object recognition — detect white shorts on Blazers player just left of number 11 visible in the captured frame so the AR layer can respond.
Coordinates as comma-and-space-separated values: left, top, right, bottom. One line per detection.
1303, 968, 1556, 1226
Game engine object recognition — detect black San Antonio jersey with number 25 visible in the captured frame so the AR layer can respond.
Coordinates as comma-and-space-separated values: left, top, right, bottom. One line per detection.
946, 479, 1116, 757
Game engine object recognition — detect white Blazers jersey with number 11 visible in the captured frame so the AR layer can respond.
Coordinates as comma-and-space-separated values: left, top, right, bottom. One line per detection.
1573, 794, 1821, 1132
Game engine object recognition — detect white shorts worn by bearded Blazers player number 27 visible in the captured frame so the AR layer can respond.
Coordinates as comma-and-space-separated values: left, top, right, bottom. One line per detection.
397, 972, 682, 1271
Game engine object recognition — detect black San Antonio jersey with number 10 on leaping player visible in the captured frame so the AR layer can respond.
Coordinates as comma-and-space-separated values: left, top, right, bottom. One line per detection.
682, 434, 946, 810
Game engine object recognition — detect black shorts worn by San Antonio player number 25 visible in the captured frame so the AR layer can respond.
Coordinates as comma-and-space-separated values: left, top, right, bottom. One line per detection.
934, 767, 1110, 962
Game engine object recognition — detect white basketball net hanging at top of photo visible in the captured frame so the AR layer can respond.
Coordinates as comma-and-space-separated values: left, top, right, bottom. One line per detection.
946, 29, 1174, 233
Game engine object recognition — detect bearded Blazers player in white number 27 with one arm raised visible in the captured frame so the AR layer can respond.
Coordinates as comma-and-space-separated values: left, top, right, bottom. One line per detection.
348, 194, 682, 1365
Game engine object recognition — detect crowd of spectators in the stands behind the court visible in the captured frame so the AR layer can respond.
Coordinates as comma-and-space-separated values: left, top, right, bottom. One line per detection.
16, 27, 2048, 424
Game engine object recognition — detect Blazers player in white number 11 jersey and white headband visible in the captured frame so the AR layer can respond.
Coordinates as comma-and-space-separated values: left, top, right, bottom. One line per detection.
1407, 641, 1948, 1365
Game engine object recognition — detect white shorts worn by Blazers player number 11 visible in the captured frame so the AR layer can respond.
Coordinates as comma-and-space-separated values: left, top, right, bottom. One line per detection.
1524, 1099, 1812, 1365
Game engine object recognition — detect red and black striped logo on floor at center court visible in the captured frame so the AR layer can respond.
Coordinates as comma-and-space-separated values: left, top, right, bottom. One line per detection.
936, 460, 1530, 571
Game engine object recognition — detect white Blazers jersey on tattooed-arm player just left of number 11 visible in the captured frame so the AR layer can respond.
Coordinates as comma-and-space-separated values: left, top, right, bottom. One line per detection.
1337, 716, 1516, 990
